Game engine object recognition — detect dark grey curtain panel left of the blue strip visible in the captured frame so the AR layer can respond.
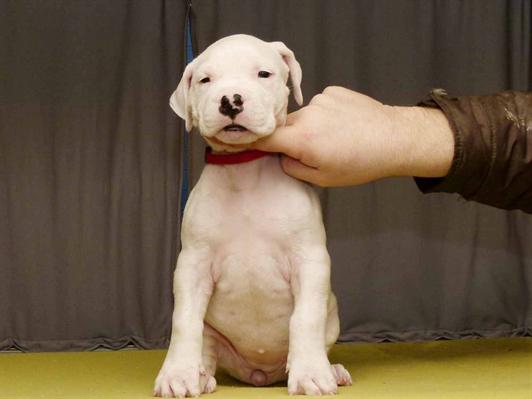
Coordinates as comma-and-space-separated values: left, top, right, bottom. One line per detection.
0, 0, 185, 350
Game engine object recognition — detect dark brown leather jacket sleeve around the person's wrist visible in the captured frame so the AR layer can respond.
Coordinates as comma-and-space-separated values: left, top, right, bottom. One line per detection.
415, 90, 532, 213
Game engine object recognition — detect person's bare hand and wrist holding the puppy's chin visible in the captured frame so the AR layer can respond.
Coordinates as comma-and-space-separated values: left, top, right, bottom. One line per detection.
249, 87, 454, 186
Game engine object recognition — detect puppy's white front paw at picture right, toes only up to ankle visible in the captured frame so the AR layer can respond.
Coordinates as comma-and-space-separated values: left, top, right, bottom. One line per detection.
288, 358, 338, 396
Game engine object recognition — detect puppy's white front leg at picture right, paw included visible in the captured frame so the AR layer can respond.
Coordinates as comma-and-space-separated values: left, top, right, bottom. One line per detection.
287, 247, 337, 395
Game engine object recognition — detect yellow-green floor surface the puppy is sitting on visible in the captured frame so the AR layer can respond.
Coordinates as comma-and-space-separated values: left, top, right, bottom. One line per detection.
0, 338, 532, 399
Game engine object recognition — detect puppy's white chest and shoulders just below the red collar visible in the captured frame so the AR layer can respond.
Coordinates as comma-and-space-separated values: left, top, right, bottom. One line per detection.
186, 170, 319, 280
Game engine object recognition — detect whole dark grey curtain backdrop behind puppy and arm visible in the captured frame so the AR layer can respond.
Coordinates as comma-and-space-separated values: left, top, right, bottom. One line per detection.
0, 0, 532, 350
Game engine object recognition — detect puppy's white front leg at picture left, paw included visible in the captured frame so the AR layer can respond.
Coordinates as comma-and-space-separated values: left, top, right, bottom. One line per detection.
154, 249, 213, 397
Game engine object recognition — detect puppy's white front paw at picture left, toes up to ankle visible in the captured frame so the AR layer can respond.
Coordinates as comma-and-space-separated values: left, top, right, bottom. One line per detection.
153, 364, 216, 398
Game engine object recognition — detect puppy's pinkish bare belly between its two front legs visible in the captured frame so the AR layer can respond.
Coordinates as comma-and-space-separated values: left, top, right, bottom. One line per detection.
205, 251, 294, 368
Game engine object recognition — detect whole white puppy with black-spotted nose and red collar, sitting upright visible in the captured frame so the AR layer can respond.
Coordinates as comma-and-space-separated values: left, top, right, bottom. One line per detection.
154, 35, 351, 397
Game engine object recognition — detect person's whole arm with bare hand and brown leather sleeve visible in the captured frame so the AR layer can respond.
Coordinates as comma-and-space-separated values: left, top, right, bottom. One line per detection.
252, 87, 532, 212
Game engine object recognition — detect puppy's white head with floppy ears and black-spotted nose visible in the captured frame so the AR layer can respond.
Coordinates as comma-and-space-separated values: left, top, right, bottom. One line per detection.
170, 35, 303, 151
